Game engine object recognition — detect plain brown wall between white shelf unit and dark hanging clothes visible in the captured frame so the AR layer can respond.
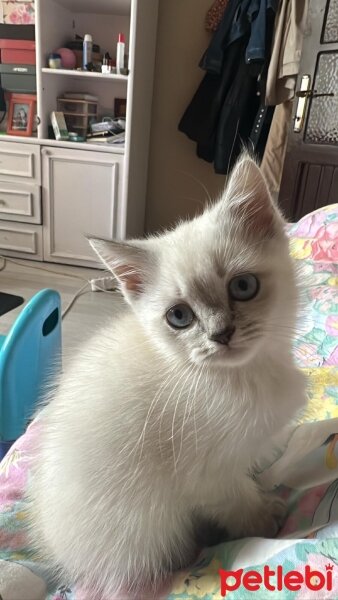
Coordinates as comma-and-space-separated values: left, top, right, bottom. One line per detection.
146, 0, 225, 232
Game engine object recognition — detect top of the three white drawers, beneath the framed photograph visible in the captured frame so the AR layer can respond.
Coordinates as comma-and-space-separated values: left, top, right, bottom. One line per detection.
0, 142, 41, 185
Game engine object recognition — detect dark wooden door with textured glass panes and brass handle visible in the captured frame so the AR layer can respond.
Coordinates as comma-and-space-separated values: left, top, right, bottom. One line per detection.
279, 0, 338, 220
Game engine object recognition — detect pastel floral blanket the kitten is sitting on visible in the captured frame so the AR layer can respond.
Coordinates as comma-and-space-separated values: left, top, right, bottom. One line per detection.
0, 204, 338, 600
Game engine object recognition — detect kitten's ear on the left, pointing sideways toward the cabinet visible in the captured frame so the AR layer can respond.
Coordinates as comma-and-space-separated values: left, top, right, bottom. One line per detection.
88, 237, 149, 300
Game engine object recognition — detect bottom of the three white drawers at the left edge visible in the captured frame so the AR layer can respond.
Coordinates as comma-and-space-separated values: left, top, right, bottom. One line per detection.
0, 221, 42, 260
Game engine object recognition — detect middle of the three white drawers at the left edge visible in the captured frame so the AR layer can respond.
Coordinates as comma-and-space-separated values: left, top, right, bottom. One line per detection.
0, 181, 41, 223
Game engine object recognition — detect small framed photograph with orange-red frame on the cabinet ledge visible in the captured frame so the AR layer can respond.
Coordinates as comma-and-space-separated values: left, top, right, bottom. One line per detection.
7, 94, 36, 137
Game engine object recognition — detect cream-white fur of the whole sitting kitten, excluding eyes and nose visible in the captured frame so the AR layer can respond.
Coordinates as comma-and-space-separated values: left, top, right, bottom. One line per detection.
26, 157, 305, 598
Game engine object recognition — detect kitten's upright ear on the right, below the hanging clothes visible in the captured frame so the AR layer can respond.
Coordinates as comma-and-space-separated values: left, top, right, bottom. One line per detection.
224, 155, 283, 236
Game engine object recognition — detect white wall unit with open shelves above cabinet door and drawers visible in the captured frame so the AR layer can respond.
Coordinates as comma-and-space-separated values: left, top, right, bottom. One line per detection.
0, 0, 159, 267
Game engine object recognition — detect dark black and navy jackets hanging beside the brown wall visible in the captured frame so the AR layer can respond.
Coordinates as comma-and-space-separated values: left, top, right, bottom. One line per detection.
179, 0, 278, 173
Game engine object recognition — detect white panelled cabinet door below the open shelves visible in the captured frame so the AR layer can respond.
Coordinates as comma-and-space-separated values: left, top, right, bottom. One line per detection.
42, 147, 123, 267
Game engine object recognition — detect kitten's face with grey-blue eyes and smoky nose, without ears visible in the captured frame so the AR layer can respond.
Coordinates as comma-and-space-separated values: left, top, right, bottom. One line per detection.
138, 215, 293, 366
